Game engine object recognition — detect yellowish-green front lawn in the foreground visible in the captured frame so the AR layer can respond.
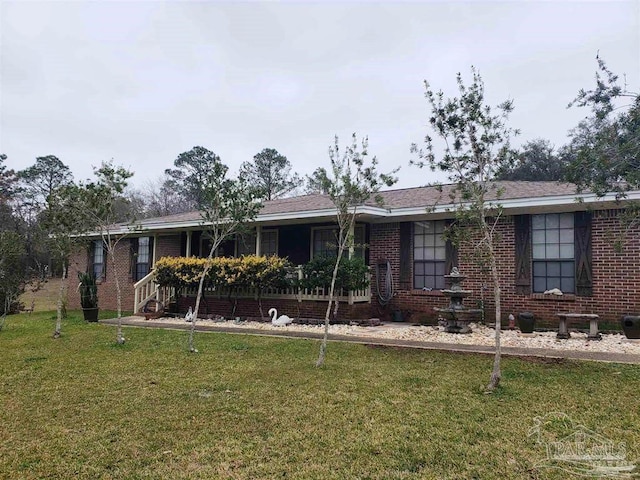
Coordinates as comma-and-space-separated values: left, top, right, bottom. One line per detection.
0, 313, 640, 479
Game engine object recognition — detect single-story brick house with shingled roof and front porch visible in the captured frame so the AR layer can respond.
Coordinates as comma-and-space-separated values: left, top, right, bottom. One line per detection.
70, 181, 640, 326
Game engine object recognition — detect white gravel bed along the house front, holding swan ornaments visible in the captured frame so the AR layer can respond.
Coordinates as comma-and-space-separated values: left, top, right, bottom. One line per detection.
151, 318, 640, 355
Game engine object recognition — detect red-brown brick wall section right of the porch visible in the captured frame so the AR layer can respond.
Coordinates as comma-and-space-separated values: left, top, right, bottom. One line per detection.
371, 211, 640, 327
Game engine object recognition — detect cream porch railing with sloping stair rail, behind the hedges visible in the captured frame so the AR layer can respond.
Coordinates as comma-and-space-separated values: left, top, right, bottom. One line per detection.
133, 267, 371, 313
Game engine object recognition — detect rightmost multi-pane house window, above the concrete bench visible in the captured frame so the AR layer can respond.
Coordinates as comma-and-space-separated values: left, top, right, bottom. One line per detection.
531, 213, 575, 293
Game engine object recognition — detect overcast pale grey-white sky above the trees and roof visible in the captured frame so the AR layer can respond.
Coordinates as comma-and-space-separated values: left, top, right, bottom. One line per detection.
0, 0, 640, 191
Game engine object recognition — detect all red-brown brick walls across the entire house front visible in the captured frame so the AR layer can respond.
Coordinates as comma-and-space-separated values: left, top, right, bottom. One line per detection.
69, 211, 640, 327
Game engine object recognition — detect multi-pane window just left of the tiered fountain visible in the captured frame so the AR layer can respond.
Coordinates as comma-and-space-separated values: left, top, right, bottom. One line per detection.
413, 220, 447, 290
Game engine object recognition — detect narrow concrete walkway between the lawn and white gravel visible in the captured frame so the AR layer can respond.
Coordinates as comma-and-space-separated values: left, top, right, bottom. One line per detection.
100, 317, 640, 365
